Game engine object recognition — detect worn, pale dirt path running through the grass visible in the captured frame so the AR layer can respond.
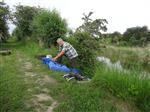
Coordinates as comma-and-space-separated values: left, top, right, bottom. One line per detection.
17, 53, 58, 112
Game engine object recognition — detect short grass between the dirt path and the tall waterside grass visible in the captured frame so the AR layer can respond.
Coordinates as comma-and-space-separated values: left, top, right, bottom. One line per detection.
20, 43, 122, 112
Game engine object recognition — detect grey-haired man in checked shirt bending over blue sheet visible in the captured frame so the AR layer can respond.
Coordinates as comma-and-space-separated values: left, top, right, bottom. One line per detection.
53, 38, 83, 80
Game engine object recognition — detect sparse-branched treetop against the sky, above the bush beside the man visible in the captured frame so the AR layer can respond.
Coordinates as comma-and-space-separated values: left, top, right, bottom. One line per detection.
76, 12, 108, 38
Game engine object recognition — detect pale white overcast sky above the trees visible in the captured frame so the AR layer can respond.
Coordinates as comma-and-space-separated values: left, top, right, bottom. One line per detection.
4, 0, 150, 33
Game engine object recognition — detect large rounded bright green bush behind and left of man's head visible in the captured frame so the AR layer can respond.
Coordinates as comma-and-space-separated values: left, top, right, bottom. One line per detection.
33, 10, 67, 46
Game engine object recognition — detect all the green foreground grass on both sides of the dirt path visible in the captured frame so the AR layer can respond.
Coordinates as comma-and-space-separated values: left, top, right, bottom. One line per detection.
0, 42, 149, 112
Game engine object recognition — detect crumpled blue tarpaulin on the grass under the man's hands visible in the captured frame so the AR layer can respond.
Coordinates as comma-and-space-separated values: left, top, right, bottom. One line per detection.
42, 57, 79, 74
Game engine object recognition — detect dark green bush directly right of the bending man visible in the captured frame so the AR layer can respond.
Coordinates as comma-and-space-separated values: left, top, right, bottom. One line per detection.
67, 33, 99, 76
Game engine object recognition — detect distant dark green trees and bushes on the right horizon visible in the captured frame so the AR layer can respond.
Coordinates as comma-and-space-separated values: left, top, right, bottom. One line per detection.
103, 26, 150, 47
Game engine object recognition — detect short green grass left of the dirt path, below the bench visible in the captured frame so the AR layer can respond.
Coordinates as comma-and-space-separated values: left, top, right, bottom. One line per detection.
0, 51, 25, 112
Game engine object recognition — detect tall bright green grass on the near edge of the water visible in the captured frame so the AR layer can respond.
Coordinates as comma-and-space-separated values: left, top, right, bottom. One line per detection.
92, 65, 150, 112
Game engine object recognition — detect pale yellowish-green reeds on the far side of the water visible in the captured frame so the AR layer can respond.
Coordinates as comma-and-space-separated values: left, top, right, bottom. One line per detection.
98, 46, 150, 72
